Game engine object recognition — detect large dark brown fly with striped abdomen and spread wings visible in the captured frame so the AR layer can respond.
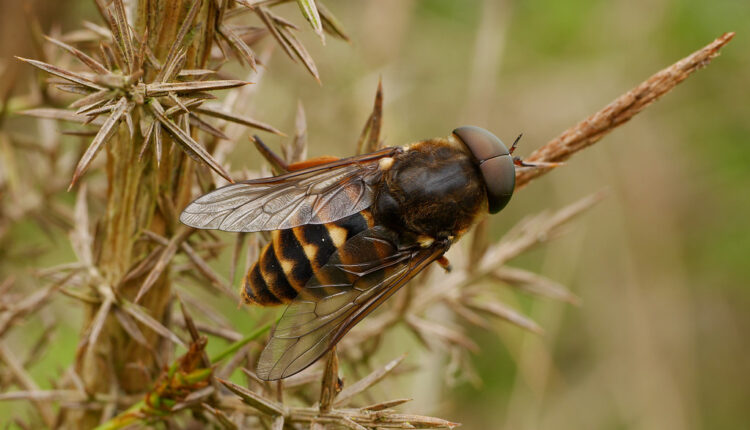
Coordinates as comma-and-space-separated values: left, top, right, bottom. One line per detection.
180, 126, 526, 380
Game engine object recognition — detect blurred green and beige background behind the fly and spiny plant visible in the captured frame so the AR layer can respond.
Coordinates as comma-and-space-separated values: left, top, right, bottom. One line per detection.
0, 0, 750, 429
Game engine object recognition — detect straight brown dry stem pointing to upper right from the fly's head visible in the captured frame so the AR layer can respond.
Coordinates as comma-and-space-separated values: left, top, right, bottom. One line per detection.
516, 33, 734, 189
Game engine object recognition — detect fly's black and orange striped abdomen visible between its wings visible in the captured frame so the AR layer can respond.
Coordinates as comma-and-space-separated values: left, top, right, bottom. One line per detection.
241, 210, 373, 306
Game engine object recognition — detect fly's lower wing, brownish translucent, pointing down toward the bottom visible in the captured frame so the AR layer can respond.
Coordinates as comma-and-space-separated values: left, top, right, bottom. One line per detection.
258, 226, 448, 380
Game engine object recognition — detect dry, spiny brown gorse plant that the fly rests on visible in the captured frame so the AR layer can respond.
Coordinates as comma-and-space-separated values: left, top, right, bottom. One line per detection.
0, 0, 732, 430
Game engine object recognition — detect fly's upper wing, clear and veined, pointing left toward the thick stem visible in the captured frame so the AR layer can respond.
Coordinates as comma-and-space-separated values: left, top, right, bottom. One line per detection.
180, 148, 397, 232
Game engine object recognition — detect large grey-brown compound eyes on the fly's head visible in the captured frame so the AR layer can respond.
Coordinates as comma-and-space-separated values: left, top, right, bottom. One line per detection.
453, 126, 516, 214
